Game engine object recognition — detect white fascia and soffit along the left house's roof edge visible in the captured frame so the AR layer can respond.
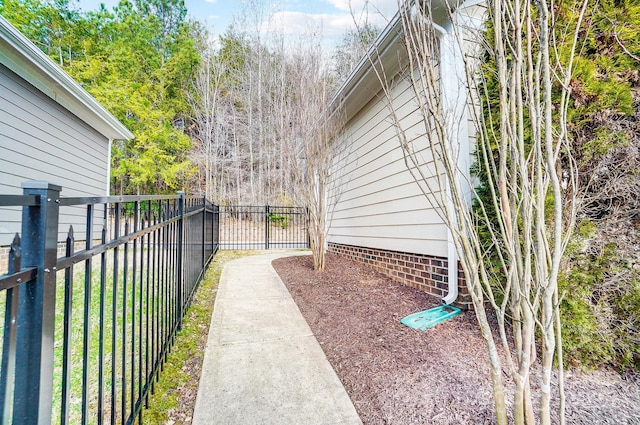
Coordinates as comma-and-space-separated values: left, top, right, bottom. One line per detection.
0, 16, 134, 140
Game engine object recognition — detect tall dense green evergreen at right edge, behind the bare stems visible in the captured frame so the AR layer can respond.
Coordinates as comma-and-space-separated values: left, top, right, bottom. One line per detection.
475, 0, 640, 369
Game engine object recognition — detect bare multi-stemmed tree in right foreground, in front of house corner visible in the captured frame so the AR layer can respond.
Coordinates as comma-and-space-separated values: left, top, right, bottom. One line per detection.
356, 0, 587, 424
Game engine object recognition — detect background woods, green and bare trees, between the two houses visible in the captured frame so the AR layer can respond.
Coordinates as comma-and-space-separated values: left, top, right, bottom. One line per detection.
0, 0, 368, 204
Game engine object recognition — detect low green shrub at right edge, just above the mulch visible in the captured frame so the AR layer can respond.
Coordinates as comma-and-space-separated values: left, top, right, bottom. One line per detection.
559, 221, 640, 370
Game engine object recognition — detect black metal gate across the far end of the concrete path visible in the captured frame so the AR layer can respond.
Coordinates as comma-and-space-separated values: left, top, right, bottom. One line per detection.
219, 205, 309, 250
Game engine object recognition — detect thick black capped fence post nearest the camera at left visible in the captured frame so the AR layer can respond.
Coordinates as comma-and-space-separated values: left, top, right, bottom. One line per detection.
13, 181, 62, 424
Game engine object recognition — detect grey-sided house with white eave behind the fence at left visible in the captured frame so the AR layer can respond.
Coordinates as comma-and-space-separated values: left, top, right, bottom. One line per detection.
0, 17, 133, 246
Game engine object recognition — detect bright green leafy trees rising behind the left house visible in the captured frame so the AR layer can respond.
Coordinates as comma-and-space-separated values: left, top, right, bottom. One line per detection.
0, 0, 200, 194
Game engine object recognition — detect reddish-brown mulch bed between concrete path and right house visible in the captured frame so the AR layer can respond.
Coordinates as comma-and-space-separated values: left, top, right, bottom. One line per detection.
273, 255, 640, 425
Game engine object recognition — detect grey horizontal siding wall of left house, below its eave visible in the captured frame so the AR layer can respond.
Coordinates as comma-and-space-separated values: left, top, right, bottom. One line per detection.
0, 61, 109, 246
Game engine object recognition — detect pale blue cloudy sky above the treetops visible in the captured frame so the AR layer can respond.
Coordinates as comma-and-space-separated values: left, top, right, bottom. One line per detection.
79, 0, 398, 47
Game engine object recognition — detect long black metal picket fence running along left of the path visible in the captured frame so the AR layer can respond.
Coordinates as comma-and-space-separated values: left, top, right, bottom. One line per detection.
0, 182, 220, 424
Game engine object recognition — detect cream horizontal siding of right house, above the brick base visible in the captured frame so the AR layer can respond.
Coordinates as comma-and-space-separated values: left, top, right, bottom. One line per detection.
328, 70, 447, 256
